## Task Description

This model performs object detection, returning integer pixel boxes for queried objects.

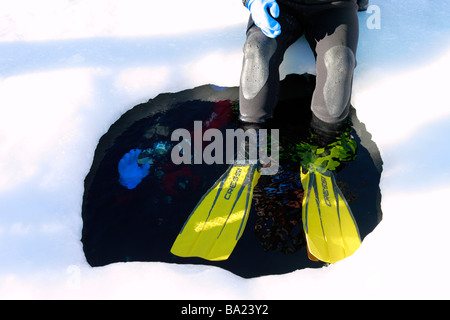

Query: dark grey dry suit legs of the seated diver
[240,0,367,124]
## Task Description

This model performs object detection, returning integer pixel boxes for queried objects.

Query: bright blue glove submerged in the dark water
[119,149,150,189]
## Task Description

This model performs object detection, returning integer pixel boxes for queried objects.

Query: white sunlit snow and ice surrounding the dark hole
[0,0,450,299]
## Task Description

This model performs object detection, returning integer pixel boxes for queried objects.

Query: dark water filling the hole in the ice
[82,75,382,278]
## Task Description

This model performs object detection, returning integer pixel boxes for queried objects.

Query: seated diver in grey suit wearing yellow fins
[171,0,368,263]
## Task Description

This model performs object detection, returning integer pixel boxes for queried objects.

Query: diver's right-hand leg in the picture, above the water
[306,0,359,124]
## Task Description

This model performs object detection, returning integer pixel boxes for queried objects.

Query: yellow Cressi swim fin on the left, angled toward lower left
[170,164,261,261]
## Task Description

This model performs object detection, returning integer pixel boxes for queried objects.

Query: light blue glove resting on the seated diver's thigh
[247,0,281,38]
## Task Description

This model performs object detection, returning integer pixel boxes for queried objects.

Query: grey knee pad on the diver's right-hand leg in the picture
[323,46,356,122]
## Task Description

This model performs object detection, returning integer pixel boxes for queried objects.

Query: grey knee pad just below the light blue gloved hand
[241,33,277,100]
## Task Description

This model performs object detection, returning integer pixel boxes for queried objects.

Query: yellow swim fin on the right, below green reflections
[300,168,361,263]
